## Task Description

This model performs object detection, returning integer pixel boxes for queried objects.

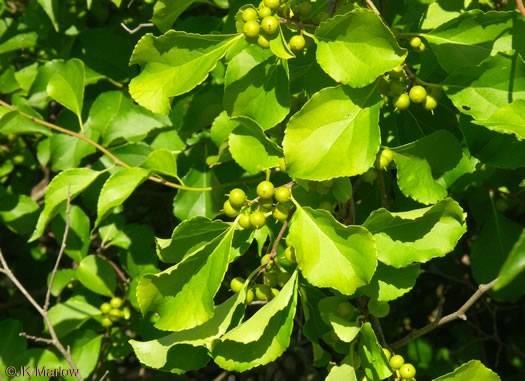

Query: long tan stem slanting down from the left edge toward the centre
[0,99,213,192]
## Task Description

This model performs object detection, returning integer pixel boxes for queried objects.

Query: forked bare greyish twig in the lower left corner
[0,188,83,381]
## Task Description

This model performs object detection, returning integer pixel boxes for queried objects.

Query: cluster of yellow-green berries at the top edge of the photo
[242,0,312,53]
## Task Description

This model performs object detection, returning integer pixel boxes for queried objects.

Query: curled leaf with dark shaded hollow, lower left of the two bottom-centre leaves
[130,289,246,374]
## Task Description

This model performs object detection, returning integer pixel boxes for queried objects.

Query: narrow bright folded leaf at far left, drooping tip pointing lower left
[29,168,102,242]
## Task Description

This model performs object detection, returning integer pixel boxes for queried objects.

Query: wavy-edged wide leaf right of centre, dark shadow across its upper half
[363,199,467,268]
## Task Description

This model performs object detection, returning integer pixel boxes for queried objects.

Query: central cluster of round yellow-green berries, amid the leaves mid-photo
[223,180,291,229]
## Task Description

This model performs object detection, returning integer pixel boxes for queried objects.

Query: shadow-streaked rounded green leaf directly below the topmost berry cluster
[224,45,290,130]
